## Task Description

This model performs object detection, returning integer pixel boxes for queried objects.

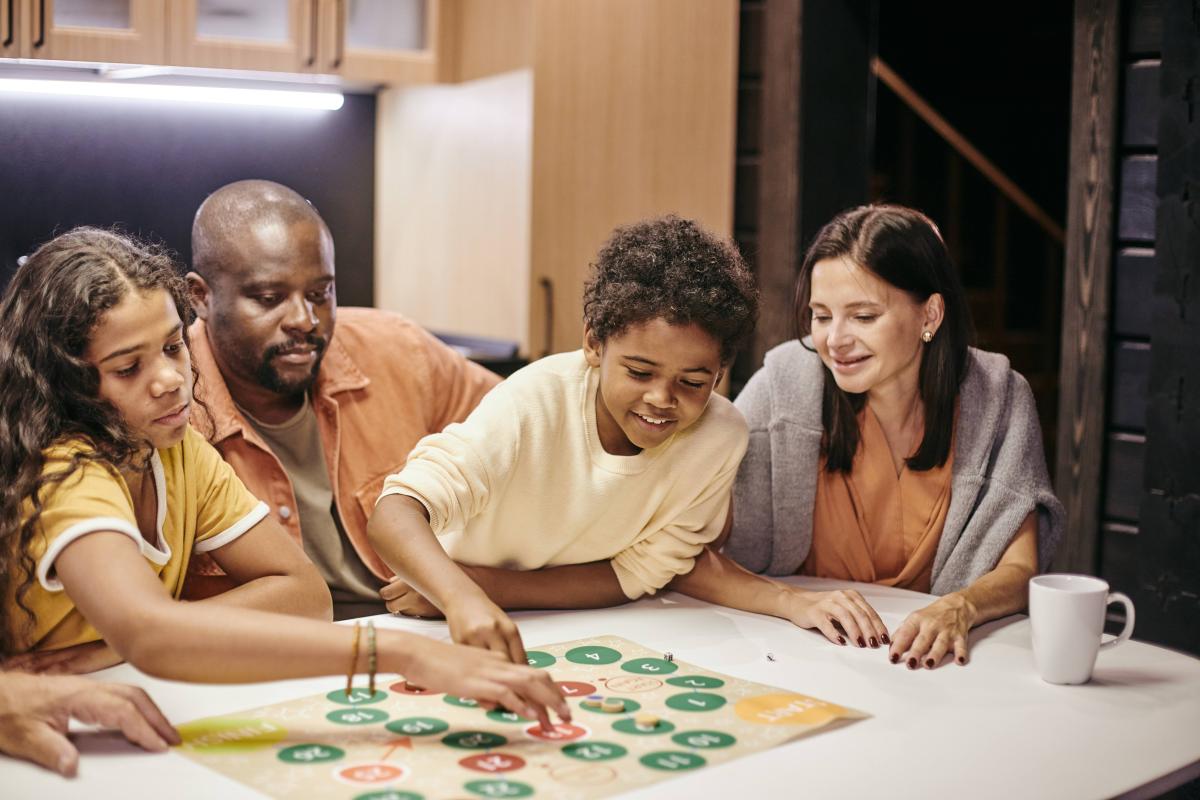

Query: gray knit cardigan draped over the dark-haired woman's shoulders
[725,339,1064,595]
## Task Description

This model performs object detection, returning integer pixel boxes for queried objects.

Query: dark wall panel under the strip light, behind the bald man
[0,95,374,305]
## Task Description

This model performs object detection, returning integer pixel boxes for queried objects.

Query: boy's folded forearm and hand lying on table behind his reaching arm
[379,560,629,616]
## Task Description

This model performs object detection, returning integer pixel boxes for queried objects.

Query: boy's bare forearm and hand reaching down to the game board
[367,494,526,664]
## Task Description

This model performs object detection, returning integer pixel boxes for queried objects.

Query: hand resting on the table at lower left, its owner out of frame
[0,673,179,777]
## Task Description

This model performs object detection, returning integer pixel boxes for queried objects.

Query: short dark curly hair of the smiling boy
[583,215,758,363]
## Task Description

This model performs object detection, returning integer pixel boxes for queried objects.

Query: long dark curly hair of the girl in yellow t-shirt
[0,228,190,656]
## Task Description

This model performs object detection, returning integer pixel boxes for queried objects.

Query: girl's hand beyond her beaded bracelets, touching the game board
[404,640,571,730]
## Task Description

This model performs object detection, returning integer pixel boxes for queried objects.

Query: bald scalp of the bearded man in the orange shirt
[192,180,332,281]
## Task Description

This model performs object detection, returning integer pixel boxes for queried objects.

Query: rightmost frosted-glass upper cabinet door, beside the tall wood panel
[317,0,443,84]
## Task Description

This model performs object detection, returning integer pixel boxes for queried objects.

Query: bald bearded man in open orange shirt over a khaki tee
[185,180,499,619]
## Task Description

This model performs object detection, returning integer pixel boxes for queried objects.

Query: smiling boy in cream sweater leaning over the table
[368,217,757,661]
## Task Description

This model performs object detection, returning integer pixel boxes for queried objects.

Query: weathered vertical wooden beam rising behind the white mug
[1054,0,1121,572]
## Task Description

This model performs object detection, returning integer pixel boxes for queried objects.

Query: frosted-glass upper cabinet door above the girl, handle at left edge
[24,0,167,64]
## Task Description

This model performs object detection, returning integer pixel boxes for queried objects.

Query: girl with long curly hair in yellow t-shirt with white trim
[0,228,568,723]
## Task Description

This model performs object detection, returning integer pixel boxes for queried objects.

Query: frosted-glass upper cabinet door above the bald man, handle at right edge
[169,0,319,72]
